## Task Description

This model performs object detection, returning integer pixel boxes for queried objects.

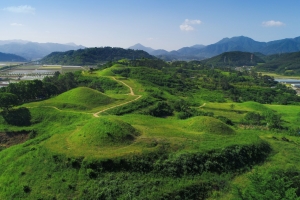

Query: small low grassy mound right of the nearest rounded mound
[187,116,235,135]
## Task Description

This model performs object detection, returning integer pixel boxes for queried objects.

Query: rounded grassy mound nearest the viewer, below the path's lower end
[70,117,138,147]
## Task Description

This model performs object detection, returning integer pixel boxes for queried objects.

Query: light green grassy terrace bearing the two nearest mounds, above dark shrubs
[39,114,259,159]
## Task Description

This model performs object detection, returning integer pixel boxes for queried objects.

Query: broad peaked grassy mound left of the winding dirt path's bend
[45,87,114,110]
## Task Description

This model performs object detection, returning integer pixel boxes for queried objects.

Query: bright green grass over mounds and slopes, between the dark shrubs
[0,65,300,199]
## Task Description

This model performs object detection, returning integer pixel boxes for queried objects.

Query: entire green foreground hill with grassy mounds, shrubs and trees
[0,55,300,199]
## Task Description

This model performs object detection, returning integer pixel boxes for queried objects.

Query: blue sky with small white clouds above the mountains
[0,0,300,50]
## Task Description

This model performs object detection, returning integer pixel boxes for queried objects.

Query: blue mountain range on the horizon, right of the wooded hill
[129,36,300,60]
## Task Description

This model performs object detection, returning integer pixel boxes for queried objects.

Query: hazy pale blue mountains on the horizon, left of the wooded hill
[0,40,85,60]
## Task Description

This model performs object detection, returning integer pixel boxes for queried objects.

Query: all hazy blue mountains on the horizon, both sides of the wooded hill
[0,36,300,61]
